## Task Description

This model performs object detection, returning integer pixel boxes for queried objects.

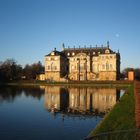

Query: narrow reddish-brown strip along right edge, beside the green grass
[134,81,140,128]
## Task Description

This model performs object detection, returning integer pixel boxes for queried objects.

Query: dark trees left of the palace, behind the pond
[0,59,44,82]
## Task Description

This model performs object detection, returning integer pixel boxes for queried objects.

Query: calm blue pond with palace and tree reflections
[0,86,124,140]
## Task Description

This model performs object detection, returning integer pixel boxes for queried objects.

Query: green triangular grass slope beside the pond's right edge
[89,85,135,136]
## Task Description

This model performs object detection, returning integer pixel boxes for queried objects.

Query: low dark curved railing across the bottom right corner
[84,129,140,140]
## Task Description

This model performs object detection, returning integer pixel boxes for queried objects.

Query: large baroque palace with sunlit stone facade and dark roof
[45,42,120,81]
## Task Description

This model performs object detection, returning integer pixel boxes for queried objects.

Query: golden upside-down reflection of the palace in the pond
[44,86,120,113]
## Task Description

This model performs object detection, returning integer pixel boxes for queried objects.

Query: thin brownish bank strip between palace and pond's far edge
[0,80,132,88]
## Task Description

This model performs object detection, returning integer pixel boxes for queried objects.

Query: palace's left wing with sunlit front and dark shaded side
[45,49,68,81]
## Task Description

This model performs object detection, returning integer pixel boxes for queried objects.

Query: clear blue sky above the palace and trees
[0,0,140,69]
